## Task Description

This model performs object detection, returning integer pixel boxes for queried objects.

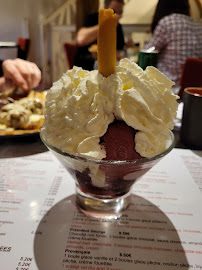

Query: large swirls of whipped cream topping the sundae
[43,59,178,159]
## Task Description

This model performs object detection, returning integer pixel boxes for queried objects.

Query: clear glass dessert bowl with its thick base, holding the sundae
[40,129,174,219]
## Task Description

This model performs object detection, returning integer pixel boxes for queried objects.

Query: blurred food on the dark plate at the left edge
[0,89,47,138]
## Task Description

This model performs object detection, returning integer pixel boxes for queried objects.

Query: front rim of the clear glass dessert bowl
[40,128,175,165]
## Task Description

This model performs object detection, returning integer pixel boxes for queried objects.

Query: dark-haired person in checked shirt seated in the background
[145,0,202,85]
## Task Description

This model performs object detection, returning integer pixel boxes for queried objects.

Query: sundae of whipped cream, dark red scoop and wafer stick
[41,10,178,219]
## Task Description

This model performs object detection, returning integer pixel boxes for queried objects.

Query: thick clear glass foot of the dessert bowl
[76,186,131,220]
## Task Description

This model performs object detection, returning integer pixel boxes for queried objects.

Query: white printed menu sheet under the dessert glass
[0,149,202,270]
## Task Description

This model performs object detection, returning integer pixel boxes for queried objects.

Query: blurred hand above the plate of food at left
[2,58,41,91]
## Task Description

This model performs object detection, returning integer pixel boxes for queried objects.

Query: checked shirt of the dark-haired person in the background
[145,13,202,84]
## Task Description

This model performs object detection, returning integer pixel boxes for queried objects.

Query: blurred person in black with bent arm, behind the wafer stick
[75,0,129,70]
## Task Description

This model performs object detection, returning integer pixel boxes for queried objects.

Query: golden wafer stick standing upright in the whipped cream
[98,9,117,77]
